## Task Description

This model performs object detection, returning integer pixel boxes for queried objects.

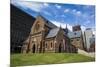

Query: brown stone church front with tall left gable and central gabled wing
[22,16,77,53]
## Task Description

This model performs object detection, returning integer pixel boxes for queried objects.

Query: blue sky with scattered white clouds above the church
[11,0,95,31]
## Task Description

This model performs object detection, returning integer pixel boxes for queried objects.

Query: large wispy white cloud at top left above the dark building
[11,0,44,12]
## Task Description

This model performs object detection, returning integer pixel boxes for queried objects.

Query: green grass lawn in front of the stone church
[10,53,95,67]
